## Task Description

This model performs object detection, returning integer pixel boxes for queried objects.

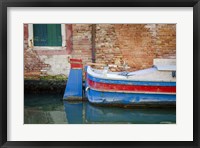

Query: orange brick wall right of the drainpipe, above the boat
[96,24,176,70]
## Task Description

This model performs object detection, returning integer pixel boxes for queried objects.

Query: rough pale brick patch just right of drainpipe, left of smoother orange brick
[95,24,123,64]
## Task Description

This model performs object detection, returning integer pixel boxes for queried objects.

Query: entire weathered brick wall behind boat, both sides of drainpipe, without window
[24,24,176,76]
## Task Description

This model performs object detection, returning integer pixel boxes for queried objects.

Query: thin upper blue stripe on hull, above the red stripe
[87,74,176,86]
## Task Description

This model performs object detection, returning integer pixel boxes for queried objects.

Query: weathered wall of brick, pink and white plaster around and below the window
[24,24,72,79]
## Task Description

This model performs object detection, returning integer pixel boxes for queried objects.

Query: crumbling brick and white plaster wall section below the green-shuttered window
[24,48,70,78]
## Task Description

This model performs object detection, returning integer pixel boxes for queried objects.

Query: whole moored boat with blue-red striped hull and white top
[85,59,176,107]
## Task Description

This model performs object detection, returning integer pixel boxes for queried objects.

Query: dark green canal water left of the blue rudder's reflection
[24,94,68,124]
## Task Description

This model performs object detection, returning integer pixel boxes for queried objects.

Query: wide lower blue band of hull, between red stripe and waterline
[87,89,176,105]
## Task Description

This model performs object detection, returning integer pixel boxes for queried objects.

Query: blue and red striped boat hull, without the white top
[86,65,176,106]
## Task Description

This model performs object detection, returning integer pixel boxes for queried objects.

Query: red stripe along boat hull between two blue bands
[87,79,176,93]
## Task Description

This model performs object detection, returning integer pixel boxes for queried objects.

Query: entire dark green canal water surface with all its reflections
[24,94,176,124]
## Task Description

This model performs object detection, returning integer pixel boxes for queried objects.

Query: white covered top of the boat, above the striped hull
[87,59,176,82]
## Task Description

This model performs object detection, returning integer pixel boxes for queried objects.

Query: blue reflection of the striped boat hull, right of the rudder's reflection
[86,104,176,124]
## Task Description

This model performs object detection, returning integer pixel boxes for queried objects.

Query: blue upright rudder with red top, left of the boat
[63,59,83,101]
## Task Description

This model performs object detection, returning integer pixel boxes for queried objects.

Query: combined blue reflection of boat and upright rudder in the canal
[64,101,176,124]
